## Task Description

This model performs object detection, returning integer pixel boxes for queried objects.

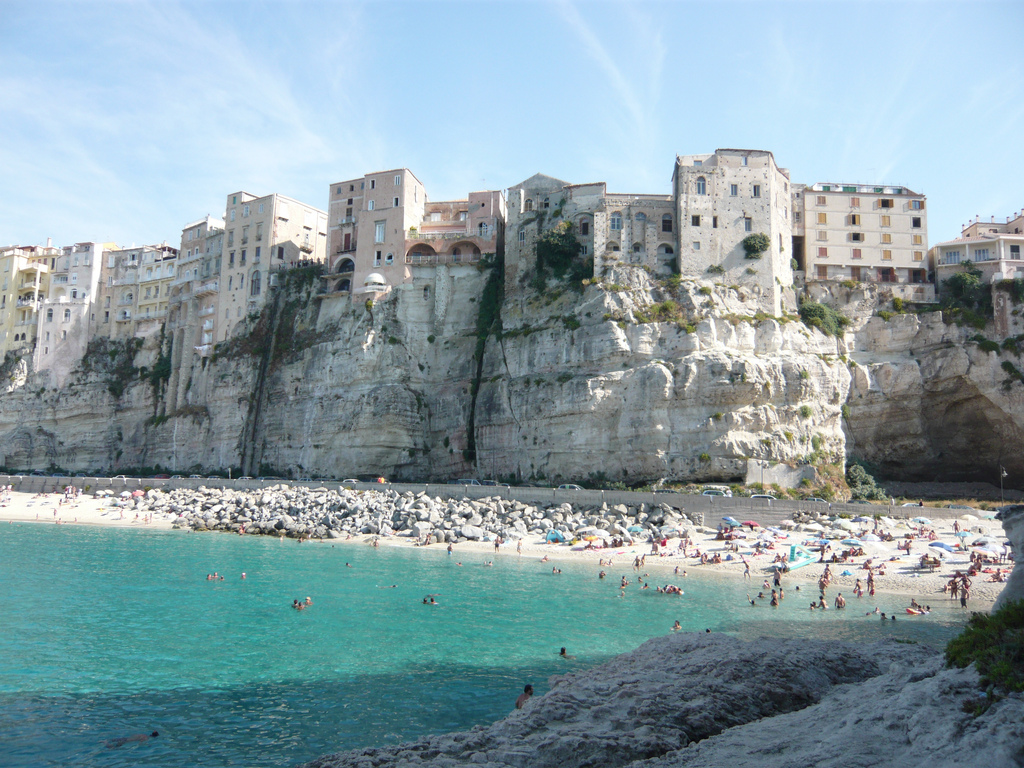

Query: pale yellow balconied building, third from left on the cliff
[92,243,178,340]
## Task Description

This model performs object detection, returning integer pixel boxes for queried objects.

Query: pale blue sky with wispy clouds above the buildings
[0,0,1024,245]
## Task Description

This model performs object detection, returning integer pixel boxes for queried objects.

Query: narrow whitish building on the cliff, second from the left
[33,243,109,386]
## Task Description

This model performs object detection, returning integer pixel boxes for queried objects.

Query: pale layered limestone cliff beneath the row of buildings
[0,265,1024,481]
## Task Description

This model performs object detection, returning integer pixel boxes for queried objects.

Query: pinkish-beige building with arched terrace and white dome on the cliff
[325,168,505,296]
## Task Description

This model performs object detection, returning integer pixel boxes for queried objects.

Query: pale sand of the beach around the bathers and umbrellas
[0,492,1013,610]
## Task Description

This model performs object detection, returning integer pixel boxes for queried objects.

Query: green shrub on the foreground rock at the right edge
[946,600,1024,691]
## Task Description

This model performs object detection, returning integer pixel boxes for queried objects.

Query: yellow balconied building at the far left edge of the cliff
[0,243,60,359]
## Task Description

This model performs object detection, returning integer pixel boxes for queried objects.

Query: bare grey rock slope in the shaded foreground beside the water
[306,634,1024,768]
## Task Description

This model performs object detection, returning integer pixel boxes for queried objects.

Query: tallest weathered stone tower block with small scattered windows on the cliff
[672,150,796,315]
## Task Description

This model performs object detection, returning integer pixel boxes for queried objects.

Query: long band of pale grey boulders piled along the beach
[126,485,703,543]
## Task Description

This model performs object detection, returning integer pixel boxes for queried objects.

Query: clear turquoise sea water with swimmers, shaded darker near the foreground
[0,524,964,768]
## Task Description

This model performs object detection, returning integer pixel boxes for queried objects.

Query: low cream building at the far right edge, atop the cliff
[930,211,1024,293]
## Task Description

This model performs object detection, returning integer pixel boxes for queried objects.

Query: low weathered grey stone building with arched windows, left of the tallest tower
[505,173,678,293]
